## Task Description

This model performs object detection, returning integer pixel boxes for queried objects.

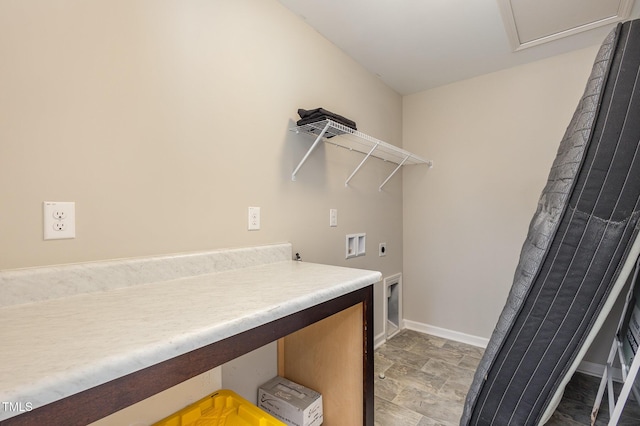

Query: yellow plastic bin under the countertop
[154,389,287,426]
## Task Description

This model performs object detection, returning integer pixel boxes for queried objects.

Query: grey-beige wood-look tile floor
[375,330,640,426]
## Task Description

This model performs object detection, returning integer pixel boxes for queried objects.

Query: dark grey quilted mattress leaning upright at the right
[460,21,640,426]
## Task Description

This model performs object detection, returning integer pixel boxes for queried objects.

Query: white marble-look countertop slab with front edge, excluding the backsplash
[0,255,381,420]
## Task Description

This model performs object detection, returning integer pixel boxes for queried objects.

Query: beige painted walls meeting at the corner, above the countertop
[0,0,624,402]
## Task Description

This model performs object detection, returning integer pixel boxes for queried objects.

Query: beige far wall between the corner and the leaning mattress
[403,46,609,360]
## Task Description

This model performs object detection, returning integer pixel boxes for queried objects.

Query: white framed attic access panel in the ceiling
[498,0,635,51]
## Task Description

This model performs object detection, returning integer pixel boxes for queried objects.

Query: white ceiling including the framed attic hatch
[279,0,640,95]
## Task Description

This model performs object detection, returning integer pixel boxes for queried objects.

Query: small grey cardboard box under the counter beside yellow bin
[258,376,322,426]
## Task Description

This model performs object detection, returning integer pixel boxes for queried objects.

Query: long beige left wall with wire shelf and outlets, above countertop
[0,0,402,340]
